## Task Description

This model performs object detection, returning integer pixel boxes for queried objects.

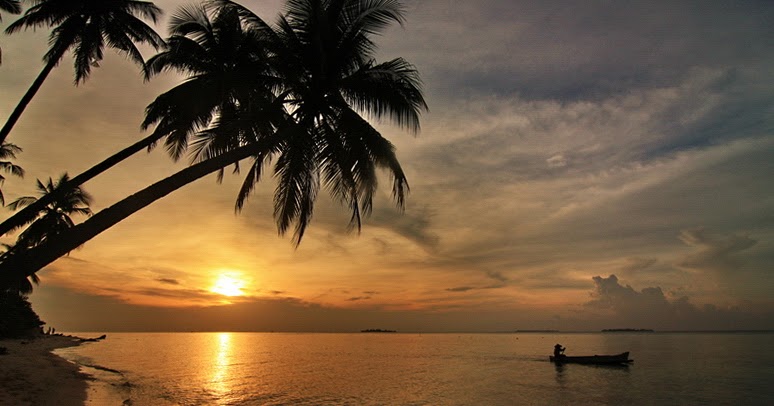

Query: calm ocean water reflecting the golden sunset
[57,333,774,405]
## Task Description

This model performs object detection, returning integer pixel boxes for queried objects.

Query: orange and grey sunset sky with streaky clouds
[0,0,774,332]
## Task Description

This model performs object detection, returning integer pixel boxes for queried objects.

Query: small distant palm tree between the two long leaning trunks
[0,173,92,295]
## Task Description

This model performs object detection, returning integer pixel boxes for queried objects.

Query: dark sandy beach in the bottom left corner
[0,335,88,406]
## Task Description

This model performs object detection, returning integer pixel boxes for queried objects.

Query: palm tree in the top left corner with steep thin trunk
[0,0,163,142]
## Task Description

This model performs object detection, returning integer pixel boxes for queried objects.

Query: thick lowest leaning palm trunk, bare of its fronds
[0,140,268,287]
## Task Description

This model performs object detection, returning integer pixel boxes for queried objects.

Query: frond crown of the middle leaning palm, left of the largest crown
[142,2,281,160]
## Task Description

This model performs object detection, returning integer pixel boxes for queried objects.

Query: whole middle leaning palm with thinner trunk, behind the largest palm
[0,0,273,235]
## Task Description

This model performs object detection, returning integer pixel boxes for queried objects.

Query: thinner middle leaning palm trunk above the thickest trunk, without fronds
[0,133,162,236]
